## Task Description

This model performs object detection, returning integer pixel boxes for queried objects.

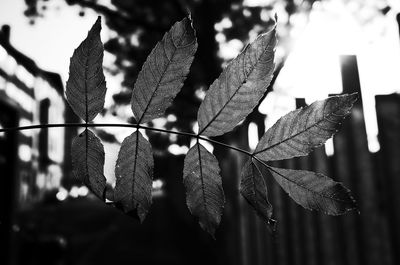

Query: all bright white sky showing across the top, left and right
[0,0,400,156]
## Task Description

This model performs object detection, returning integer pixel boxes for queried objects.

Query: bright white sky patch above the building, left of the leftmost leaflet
[0,0,96,81]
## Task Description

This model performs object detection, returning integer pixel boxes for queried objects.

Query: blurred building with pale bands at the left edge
[0,23,65,262]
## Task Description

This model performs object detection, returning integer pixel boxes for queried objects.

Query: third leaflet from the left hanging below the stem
[183,143,225,237]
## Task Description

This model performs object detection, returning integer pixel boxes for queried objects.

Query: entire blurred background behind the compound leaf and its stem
[0,0,400,265]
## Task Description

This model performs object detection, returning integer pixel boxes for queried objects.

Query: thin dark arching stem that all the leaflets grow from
[0,123,252,156]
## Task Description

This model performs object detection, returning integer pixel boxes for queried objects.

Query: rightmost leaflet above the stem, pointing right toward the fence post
[254,93,357,161]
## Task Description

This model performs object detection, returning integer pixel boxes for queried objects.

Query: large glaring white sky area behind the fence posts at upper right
[267,0,400,152]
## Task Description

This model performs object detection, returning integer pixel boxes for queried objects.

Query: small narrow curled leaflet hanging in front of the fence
[240,159,272,223]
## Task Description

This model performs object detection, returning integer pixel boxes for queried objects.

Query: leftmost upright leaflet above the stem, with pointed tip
[65,17,107,122]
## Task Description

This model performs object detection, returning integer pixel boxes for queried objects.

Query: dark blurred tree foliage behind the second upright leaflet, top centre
[25,0,314,150]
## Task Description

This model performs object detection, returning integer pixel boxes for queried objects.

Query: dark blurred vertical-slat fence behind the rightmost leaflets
[230,46,400,265]
